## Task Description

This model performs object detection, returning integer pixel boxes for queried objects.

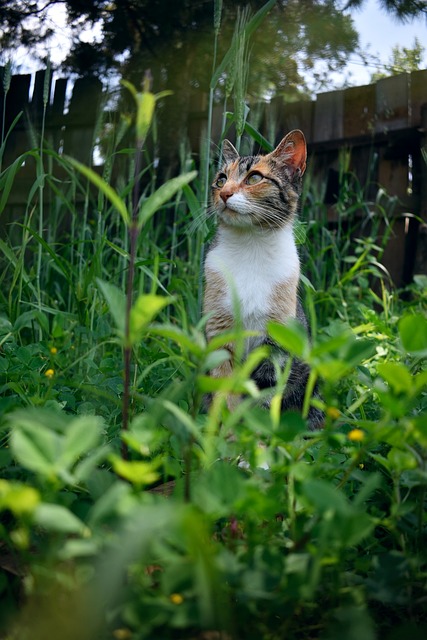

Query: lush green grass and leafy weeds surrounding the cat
[0,16,427,640]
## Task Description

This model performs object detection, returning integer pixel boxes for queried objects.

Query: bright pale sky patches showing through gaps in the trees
[7,0,427,87]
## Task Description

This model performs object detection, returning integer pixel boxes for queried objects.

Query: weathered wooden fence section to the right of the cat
[260,70,427,286]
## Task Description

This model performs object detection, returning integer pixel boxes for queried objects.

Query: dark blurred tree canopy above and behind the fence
[0,0,425,166]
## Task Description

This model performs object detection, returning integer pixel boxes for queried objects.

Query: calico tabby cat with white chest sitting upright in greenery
[203,129,323,429]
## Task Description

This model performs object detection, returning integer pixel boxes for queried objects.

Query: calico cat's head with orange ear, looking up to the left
[212,129,307,229]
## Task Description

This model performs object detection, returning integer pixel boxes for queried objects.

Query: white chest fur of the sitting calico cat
[206,225,299,330]
